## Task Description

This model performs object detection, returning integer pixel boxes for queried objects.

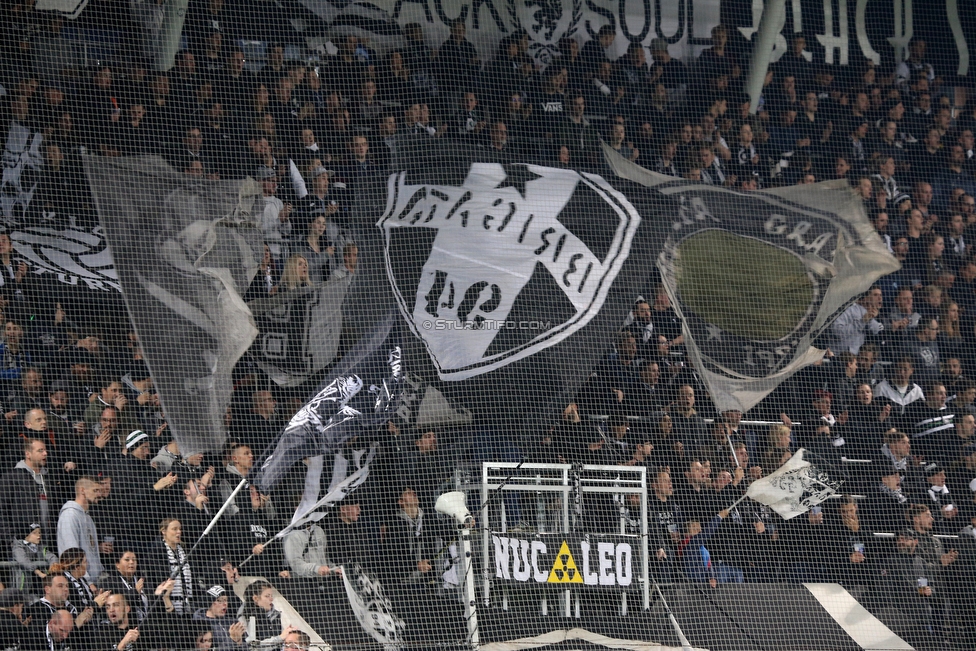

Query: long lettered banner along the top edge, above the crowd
[299,0,976,76]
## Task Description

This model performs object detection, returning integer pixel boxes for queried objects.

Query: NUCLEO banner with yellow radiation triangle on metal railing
[488,533,641,590]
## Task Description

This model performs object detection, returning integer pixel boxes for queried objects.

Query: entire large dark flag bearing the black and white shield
[364,139,656,427]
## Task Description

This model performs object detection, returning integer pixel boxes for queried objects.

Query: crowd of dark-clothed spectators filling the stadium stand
[0,0,976,651]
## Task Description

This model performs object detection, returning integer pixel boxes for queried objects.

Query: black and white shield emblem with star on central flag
[379,163,640,380]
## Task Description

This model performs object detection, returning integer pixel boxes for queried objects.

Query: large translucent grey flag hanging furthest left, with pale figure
[85,157,263,454]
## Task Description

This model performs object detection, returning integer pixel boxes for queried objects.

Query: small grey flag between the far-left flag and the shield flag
[248,274,353,387]
